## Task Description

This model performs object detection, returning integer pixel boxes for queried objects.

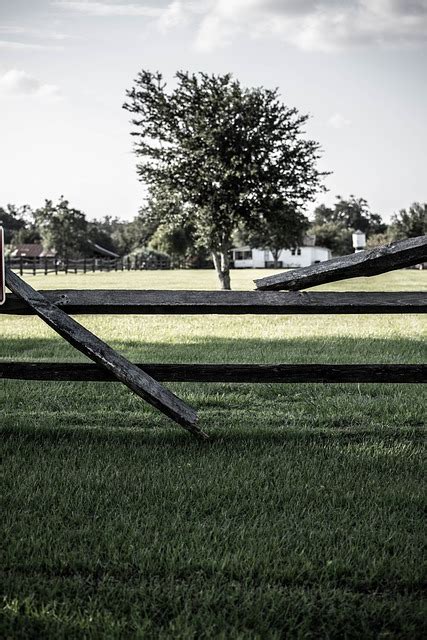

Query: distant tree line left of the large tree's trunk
[0,196,209,267]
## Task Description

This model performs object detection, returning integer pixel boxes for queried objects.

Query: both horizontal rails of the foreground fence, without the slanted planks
[0,289,427,383]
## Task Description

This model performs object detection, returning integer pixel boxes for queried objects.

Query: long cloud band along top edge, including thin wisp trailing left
[51,0,427,52]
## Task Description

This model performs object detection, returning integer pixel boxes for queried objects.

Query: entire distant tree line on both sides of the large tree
[0,192,427,267]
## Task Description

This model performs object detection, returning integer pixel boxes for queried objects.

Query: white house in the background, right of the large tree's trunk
[231,236,332,269]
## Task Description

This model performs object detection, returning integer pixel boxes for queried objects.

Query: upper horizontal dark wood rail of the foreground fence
[0,289,427,315]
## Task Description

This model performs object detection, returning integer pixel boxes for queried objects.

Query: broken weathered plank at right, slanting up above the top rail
[255,236,427,291]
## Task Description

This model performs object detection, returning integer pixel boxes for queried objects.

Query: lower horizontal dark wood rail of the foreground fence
[0,362,427,383]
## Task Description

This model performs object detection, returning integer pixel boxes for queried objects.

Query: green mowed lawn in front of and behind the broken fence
[0,270,427,639]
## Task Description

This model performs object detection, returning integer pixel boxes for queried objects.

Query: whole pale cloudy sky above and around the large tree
[0,0,427,219]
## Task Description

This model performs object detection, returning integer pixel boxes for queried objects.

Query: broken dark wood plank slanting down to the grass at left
[6,268,207,438]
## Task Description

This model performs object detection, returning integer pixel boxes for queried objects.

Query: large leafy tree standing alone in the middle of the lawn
[124,70,323,289]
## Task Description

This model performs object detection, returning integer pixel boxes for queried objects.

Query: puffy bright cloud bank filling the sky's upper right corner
[195,0,427,51]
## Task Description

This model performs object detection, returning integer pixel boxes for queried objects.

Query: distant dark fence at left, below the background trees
[6,256,171,276]
